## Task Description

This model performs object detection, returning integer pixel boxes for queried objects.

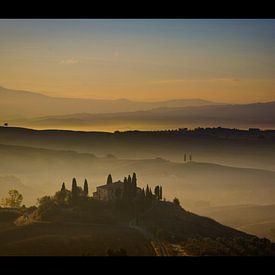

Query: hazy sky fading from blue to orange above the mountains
[0,19,275,102]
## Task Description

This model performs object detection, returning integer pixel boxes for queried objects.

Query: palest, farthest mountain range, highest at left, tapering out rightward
[0,87,219,120]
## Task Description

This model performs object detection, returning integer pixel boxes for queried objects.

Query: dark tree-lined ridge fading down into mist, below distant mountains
[0,127,275,171]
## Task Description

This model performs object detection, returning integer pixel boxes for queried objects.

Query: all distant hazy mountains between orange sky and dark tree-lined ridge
[0,87,275,131]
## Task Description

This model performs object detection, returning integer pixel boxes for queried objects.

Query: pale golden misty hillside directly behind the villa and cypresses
[0,142,275,206]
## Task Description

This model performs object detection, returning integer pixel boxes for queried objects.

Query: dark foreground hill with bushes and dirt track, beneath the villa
[0,177,275,256]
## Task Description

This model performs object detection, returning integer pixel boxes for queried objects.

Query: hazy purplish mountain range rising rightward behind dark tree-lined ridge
[11,102,275,130]
